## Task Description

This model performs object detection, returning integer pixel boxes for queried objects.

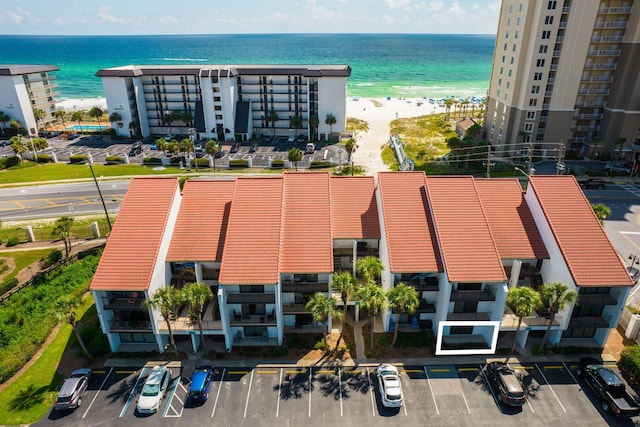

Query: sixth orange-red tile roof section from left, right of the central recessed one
[378,172,443,273]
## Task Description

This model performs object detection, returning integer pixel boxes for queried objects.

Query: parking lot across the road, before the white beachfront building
[0,135,347,168]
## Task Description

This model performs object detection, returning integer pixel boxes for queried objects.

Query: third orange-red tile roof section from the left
[218,177,283,285]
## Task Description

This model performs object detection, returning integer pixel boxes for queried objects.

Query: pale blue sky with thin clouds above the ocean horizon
[0,0,500,35]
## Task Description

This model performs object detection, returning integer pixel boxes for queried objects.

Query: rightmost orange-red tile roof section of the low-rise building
[530,176,633,286]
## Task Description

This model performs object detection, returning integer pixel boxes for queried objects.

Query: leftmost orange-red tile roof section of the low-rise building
[91,177,179,291]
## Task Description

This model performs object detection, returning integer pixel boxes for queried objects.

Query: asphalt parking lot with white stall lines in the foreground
[37,363,633,427]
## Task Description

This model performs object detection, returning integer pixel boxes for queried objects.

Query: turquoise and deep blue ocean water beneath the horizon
[0,34,495,99]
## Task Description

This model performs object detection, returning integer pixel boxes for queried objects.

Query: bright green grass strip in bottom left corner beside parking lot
[0,296,93,425]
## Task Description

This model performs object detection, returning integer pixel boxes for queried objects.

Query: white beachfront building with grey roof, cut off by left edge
[0,64,60,136]
